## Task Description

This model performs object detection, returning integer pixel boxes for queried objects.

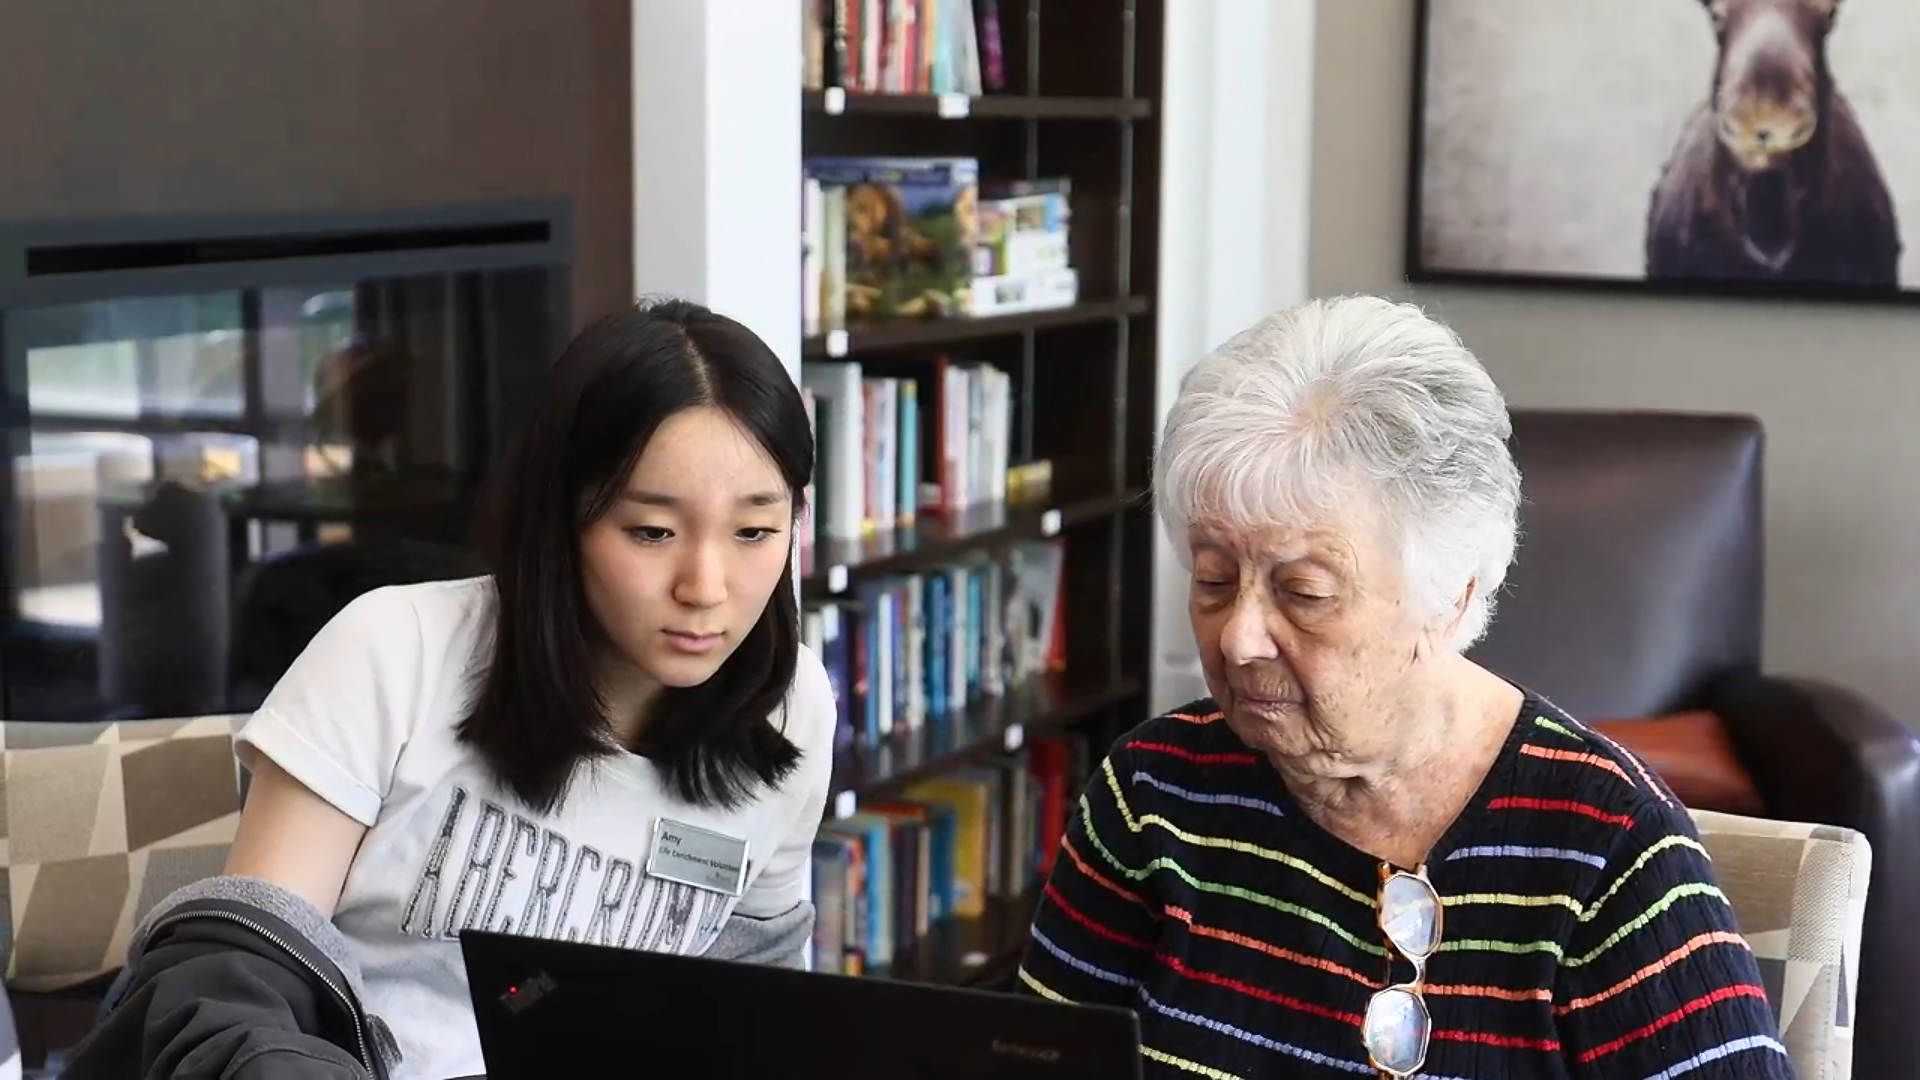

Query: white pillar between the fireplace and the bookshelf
[632,0,803,375]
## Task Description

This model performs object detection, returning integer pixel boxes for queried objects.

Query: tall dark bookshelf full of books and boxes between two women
[793,0,1165,986]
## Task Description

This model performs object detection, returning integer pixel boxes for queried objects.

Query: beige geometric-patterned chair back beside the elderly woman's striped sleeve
[1692,811,1874,1080]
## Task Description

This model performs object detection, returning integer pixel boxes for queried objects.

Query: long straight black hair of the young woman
[459,300,814,811]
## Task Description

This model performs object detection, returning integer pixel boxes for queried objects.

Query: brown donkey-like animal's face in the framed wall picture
[1705,0,1839,173]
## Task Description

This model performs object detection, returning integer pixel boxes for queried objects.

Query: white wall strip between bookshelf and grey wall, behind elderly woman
[1152,0,1315,709]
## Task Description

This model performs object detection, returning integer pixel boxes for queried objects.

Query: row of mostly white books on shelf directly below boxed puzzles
[801,357,1014,538]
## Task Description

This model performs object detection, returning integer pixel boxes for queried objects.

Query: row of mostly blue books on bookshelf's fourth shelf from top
[801,538,1066,748]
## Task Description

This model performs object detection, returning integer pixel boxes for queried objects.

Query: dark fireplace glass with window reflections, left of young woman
[6,271,529,719]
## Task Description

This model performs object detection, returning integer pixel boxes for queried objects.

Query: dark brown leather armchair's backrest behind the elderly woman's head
[1469,409,1763,721]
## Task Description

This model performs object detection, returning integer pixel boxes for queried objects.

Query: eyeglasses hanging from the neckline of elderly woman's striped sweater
[1359,863,1440,1080]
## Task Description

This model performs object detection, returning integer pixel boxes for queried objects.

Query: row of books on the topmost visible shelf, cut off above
[801,0,1006,96]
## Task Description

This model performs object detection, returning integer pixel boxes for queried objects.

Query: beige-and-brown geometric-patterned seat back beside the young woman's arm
[0,717,246,990]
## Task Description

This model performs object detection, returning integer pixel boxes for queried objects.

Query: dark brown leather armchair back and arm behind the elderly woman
[1473,409,1920,1076]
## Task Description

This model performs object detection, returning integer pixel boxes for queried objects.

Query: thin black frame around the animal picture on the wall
[1402,0,1920,307]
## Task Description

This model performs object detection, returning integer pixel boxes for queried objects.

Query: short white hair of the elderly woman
[1154,296,1521,651]
